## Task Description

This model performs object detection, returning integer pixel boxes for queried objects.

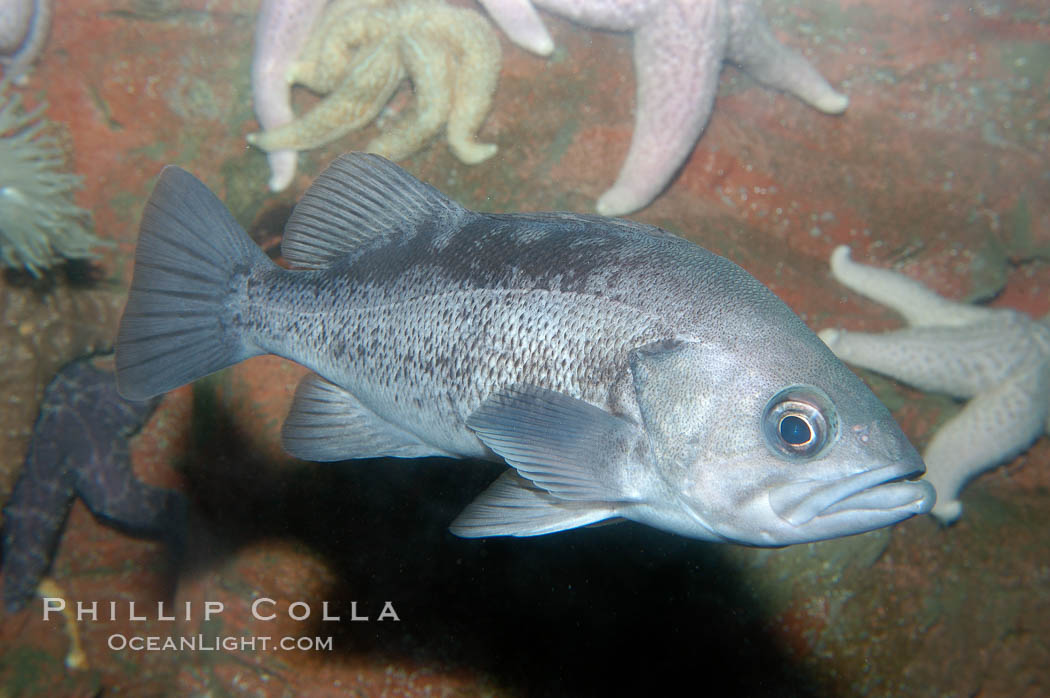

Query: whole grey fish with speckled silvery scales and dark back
[117,153,935,546]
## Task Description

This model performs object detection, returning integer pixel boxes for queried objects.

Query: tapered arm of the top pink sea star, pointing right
[727,2,849,114]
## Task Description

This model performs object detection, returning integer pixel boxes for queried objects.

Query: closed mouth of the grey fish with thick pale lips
[770,461,937,535]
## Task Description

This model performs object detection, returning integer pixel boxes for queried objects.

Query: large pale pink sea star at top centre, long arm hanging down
[480,0,848,215]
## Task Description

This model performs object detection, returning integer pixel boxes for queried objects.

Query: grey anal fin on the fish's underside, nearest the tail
[280,374,449,461]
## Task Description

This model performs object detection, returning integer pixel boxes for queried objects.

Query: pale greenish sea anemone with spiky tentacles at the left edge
[0,79,103,276]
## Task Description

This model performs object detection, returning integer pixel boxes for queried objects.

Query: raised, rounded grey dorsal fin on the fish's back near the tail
[280,152,467,269]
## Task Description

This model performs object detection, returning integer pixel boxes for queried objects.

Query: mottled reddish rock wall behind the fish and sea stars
[0,0,1050,697]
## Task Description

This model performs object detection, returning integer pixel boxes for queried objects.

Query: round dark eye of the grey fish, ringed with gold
[762,385,836,459]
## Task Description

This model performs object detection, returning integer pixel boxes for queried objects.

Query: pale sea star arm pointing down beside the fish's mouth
[923,364,1050,524]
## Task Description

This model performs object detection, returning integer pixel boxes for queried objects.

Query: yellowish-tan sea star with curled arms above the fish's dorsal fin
[248,0,502,164]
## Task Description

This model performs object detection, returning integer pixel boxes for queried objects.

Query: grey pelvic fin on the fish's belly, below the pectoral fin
[448,470,617,538]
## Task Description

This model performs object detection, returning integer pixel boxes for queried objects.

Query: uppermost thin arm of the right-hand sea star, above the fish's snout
[831,245,988,327]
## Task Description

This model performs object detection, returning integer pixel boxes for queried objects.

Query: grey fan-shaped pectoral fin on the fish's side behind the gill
[466,385,645,503]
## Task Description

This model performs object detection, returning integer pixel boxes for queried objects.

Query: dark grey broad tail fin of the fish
[117,166,273,400]
